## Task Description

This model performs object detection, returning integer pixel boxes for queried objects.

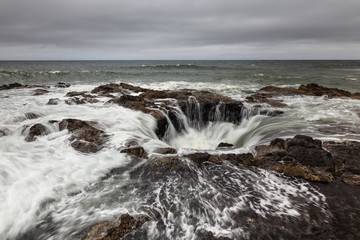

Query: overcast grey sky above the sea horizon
[0,0,360,60]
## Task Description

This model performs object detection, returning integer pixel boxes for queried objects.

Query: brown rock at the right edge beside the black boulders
[323,141,360,185]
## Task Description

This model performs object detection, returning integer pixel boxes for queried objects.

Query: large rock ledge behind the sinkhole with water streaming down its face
[102,84,243,138]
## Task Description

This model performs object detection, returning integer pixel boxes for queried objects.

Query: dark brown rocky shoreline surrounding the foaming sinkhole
[0,83,360,240]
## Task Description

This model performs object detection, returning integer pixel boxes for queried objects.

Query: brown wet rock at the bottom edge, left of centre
[83,214,150,240]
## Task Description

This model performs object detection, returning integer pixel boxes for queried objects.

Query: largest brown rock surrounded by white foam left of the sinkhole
[59,119,108,153]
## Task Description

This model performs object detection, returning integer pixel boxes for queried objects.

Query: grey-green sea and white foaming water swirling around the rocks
[0,60,360,240]
